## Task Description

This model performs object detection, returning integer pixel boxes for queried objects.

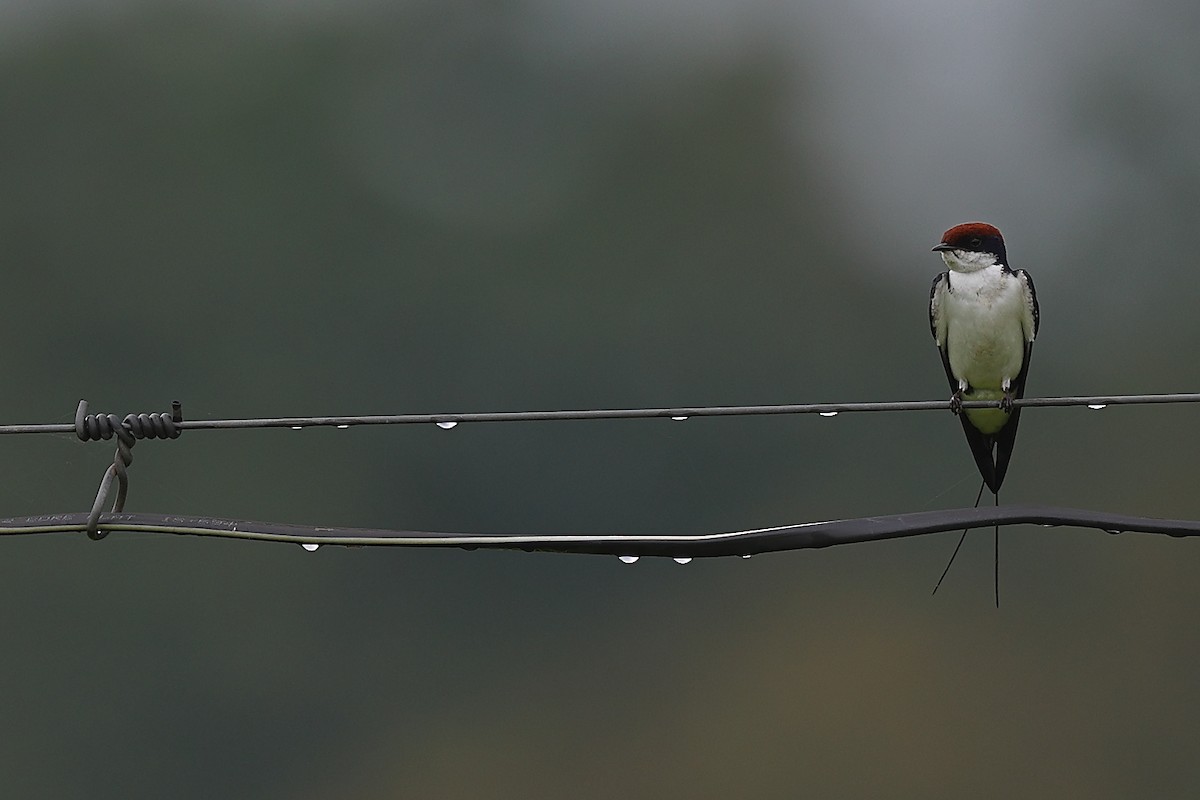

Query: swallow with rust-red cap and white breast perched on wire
[929,222,1040,607]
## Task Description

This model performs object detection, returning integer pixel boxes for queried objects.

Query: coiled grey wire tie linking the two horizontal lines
[76,399,184,541]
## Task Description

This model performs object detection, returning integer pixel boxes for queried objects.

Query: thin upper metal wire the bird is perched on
[0,392,1200,434]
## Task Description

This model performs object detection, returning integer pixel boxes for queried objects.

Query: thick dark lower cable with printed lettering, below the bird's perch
[0,506,1200,561]
